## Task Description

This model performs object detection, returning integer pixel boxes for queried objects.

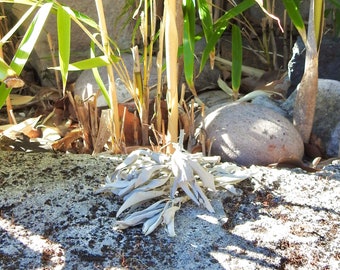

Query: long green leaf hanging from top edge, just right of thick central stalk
[183,0,196,95]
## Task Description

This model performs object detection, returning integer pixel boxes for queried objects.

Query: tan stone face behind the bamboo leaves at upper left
[9,0,133,85]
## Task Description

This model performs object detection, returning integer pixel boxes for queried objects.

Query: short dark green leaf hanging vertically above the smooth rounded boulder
[231,25,242,98]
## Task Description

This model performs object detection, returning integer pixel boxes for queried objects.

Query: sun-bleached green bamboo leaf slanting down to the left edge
[0,3,53,108]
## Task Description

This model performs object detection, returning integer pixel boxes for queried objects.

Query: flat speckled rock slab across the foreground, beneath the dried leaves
[0,151,340,269]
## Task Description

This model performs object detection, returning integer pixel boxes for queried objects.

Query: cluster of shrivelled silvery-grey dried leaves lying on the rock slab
[99,147,251,236]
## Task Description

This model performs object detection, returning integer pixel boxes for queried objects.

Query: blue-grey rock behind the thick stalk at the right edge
[282,79,340,157]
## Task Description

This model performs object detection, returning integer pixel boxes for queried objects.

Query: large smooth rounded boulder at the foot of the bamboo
[205,103,304,166]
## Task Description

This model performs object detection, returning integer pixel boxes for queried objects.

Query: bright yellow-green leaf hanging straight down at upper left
[57,6,71,91]
